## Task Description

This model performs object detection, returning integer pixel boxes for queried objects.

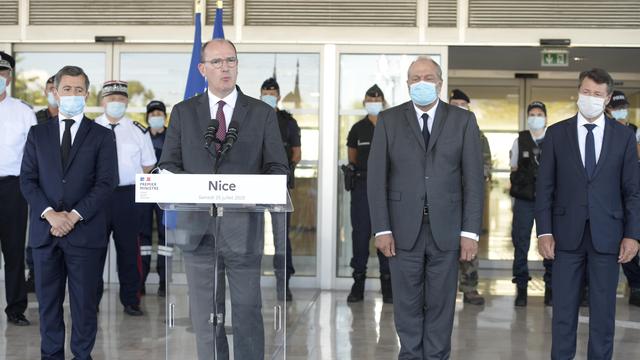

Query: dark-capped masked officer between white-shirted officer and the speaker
[138,100,173,297]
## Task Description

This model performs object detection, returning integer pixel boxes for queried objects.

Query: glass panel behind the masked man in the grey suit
[337,54,440,277]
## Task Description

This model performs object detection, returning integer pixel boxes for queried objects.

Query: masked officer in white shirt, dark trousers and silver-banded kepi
[96,80,157,316]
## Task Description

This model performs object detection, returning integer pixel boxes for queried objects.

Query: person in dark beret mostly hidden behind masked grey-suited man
[449,89,492,305]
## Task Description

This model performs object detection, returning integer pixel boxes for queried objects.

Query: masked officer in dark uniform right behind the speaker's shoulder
[260,78,302,301]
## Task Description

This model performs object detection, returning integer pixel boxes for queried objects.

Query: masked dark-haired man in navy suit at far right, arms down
[535,69,640,360]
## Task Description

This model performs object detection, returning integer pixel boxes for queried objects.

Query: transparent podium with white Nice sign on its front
[136,174,293,360]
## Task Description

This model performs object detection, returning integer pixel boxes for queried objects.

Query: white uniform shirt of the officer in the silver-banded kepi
[96,114,158,186]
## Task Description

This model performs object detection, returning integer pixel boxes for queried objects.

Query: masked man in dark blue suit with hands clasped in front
[20,66,117,360]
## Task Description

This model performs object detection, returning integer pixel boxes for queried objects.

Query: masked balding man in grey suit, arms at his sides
[367,57,484,359]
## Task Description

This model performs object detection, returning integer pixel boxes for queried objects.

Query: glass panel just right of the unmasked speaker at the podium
[238,53,320,276]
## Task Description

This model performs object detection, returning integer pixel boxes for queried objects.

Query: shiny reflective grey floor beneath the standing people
[0,271,640,360]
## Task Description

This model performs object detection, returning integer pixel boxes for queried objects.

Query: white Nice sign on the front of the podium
[136,174,287,204]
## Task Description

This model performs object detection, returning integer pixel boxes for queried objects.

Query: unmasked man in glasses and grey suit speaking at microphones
[158,39,288,359]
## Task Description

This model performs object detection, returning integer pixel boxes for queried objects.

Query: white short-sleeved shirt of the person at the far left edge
[0,95,37,177]
